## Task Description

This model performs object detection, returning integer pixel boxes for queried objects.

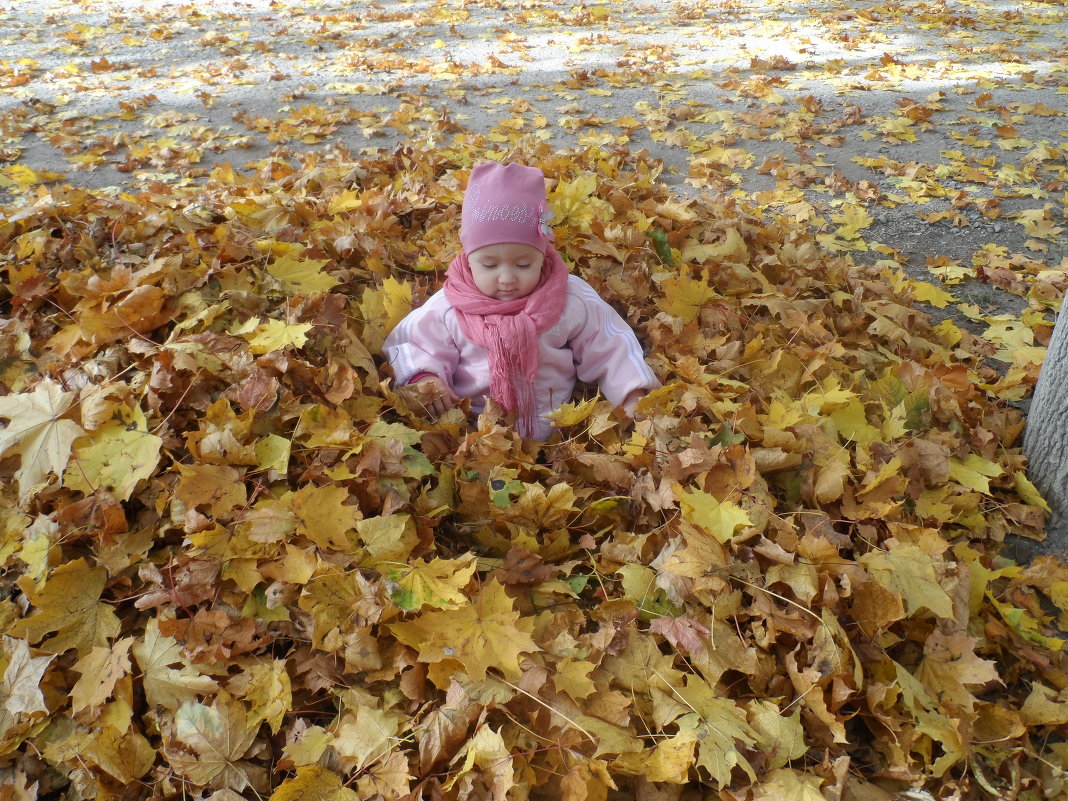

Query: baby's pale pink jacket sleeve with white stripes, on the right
[570,281,660,405]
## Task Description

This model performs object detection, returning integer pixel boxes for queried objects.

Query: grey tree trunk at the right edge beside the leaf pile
[1022,304,1068,556]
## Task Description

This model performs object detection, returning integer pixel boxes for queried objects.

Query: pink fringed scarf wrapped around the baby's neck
[445,245,567,436]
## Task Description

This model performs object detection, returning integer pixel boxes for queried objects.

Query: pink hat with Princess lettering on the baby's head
[460,161,553,253]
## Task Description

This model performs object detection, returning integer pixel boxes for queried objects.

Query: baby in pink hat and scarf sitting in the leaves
[382,162,660,440]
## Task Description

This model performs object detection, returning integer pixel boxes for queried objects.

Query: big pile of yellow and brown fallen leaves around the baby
[0,138,1068,801]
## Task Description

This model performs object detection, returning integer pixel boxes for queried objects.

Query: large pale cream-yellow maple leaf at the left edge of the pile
[0,379,84,501]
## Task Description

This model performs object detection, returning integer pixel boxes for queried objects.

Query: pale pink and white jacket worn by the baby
[382,276,660,439]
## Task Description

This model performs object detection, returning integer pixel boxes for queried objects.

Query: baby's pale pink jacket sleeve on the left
[382,298,459,389]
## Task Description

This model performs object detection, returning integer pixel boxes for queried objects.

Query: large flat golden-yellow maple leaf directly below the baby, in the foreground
[389,580,540,681]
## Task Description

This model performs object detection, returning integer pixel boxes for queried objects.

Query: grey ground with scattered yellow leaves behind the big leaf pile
[0,0,1068,410]
